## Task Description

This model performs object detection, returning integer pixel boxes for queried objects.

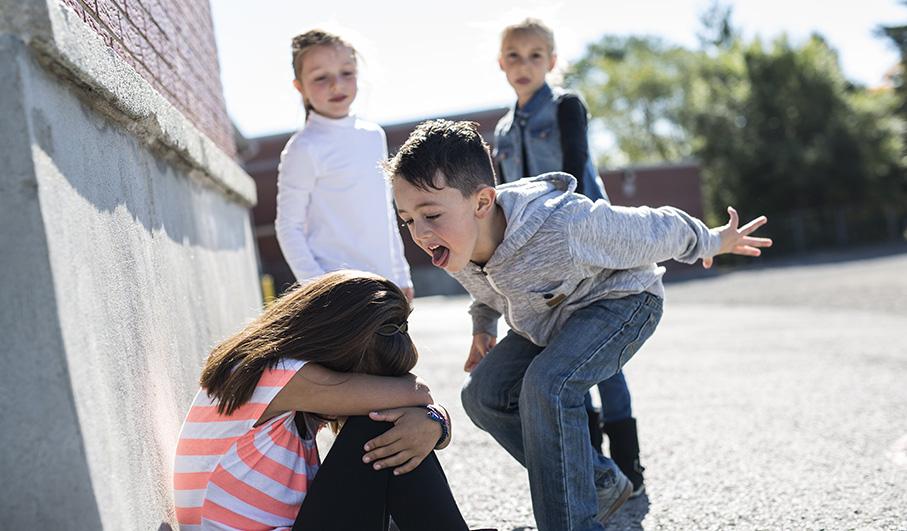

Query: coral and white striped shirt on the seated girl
[173,358,320,531]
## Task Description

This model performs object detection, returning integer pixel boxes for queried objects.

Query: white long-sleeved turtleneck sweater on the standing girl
[274,111,412,288]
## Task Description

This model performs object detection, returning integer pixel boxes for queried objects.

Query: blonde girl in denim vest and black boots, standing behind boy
[494,18,645,497]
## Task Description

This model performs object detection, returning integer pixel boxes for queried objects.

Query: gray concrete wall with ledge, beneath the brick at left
[0,0,260,530]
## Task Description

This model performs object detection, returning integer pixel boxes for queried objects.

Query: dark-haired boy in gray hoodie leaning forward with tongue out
[385,120,771,531]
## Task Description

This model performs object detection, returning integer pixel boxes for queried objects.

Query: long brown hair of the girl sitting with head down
[200,270,418,415]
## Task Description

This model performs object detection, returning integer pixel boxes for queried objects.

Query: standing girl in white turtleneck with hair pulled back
[275,30,413,299]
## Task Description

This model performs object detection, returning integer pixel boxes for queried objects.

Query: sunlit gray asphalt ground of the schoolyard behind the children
[411,250,907,531]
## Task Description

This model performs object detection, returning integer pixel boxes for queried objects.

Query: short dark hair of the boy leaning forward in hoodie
[384,120,497,197]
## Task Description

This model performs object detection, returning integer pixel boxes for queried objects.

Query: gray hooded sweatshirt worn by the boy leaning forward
[452,172,721,346]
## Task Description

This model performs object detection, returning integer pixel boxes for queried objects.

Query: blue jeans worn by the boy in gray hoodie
[461,293,662,531]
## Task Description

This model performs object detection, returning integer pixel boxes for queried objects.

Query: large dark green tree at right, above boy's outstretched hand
[688,35,903,224]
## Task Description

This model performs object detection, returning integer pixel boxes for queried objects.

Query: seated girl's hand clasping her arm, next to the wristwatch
[362,407,441,476]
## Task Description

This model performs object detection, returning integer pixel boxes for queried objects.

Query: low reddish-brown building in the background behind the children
[243,107,703,296]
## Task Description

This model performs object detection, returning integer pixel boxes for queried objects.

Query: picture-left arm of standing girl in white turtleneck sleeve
[274,139,325,282]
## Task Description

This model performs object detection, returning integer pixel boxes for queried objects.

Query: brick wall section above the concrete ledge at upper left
[59,0,236,156]
